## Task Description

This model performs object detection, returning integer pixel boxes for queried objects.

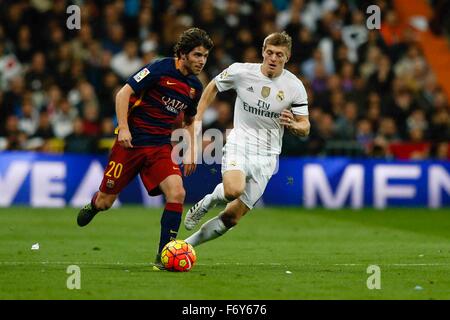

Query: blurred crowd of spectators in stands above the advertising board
[0,0,450,159]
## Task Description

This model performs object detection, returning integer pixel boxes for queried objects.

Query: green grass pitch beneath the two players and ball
[0,205,450,300]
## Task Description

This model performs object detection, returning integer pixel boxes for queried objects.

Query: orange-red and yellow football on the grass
[161,240,197,272]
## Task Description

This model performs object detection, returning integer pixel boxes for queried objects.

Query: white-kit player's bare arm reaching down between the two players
[184,79,218,176]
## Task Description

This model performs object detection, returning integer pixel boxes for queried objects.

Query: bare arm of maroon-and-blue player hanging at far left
[116,84,134,148]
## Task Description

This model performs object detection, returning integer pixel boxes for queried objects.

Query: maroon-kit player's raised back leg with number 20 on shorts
[77,142,145,227]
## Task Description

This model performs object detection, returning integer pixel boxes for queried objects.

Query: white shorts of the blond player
[222,144,278,209]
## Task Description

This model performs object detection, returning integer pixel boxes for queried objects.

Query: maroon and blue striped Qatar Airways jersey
[127,58,203,147]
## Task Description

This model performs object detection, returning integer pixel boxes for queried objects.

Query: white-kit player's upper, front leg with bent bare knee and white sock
[184,170,245,230]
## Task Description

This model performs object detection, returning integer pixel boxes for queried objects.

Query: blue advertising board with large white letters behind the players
[0,152,450,208]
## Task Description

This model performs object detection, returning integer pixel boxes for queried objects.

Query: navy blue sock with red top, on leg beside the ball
[158,203,183,253]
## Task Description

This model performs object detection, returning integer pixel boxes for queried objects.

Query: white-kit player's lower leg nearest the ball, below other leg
[185,198,250,246]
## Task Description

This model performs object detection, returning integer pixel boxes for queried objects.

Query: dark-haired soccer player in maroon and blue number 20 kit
[77,28,213,269]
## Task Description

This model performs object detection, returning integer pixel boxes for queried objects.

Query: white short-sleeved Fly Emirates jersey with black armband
[214,63,308,155]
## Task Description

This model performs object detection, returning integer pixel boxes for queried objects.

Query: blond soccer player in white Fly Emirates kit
[184,32,310,246]
